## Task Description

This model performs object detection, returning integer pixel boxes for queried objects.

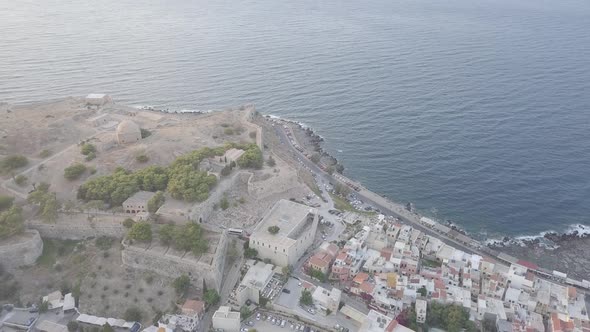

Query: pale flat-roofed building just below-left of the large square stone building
[236,261,274,306]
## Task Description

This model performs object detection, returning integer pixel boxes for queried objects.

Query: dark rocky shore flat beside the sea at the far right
[496,237,590,280]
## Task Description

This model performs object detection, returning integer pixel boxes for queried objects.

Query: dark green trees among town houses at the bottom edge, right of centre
[396,301,479,332]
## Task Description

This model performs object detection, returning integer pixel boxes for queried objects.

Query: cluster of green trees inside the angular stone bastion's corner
[158,222,209,255]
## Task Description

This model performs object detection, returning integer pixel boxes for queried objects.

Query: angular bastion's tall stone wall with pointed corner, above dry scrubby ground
[121,232,227,291]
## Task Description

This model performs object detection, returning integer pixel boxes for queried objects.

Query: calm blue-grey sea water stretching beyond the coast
[0,0,590,239]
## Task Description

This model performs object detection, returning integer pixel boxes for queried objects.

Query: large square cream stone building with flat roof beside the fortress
[250,199,318,266]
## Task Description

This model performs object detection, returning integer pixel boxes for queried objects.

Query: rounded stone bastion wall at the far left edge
[0,230,43,269]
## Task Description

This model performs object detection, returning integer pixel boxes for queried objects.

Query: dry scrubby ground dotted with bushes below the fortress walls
[13,239,176,321]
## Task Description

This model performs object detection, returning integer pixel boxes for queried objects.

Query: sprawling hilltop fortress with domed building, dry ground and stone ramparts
[0,94,310,296]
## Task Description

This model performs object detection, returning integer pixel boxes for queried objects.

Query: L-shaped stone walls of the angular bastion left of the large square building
[121,231,227,291]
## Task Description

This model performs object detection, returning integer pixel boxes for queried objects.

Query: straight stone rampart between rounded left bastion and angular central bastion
[26,213,126,240]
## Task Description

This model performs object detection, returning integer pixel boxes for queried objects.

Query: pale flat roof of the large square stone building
[252,199,315,241]
